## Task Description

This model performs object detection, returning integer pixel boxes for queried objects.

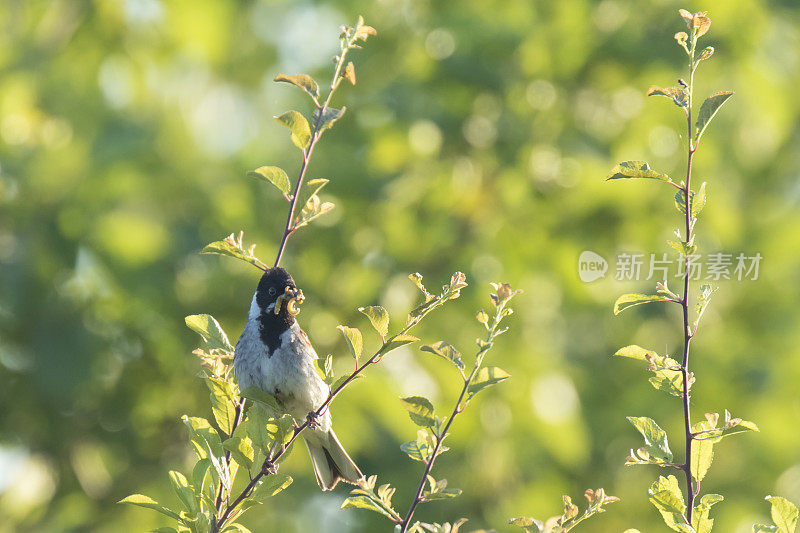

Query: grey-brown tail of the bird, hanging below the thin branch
[303,428,364,490]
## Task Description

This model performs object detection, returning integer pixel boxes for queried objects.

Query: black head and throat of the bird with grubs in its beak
[256,267,304,349]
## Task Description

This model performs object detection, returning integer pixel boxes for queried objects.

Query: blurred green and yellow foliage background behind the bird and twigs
[0,0,800,532]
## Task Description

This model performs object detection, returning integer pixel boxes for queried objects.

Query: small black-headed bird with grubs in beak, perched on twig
[233,266,364,491]
